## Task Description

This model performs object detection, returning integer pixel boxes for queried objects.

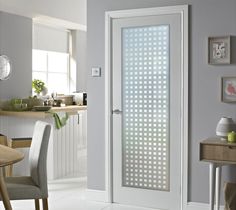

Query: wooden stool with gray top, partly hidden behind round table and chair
[6,137,32,176]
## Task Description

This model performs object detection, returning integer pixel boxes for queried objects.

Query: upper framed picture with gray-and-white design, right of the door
[208,36,231,64]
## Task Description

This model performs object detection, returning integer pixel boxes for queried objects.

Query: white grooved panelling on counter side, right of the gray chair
[48,111,87,179]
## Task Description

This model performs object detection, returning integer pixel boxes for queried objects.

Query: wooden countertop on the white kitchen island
[0,105,87,118]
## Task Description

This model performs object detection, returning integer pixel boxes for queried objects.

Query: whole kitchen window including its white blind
[32,23,76,94]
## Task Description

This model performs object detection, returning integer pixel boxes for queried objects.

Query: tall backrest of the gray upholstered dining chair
[29,121,51,196]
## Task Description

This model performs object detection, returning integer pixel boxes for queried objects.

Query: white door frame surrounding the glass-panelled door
[104,5,189,210]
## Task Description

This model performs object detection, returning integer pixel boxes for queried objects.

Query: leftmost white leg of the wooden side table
[209,163,216,210]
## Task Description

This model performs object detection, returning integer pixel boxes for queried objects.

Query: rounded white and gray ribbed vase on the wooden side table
[216,117,236,140]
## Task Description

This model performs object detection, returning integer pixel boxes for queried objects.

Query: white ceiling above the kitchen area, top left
[0,0,87,25]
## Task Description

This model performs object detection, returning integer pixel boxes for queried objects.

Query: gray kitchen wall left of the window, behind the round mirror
[0,12,32,99]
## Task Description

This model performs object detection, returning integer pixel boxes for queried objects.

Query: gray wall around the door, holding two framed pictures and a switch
[87,0,236,202]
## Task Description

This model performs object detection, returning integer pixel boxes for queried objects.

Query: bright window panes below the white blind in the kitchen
[33,49,70,93]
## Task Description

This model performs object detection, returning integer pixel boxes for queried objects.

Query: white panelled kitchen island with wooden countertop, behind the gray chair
[0,106,87,180]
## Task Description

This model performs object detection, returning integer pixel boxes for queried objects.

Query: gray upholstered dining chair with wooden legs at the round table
[3,121,51,210]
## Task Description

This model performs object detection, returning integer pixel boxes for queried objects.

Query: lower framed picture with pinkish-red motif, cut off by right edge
[221,77,236,103]
